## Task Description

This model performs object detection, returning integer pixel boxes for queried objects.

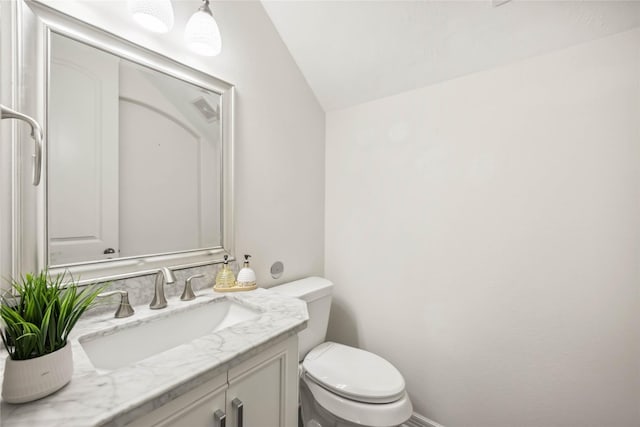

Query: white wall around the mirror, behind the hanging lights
[29,0,325,286]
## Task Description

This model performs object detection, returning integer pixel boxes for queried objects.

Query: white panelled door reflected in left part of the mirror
[48,34,119,265]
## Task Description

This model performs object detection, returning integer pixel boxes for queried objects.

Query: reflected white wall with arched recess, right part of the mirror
[118,61,221,256]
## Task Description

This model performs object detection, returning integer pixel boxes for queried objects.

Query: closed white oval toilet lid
[302,342,404,403]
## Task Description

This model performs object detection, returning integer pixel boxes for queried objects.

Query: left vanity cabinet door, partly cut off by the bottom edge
[127,375,229,427]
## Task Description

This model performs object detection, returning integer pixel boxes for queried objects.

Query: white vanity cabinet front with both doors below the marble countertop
[128,335,298,427]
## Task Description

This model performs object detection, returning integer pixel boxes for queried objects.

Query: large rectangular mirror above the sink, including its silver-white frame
[13,2,234,281]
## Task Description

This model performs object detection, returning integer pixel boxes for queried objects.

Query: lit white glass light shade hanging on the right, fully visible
[184,0,222,56]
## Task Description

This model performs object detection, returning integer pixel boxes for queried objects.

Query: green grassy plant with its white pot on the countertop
[0,271,106,403]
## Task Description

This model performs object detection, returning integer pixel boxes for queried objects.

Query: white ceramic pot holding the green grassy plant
[2,342,73,403]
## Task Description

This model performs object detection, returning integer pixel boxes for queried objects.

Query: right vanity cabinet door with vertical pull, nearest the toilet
[227,336,298,427]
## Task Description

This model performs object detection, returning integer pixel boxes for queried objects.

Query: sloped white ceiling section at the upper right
[263,0,640,111]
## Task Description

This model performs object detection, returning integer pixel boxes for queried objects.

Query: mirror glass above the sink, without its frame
[47,32,223,266]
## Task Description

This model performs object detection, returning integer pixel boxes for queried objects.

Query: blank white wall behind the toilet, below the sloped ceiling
[325,30,640,427]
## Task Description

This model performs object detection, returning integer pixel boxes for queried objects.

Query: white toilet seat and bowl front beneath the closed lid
[301,374,413,427]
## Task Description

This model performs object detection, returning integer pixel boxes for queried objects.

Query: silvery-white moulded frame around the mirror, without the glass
[11,0,235,283]
